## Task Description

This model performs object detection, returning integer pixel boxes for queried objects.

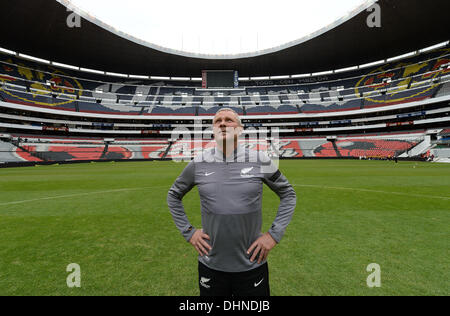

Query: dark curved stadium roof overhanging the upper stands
[0,0,450,77]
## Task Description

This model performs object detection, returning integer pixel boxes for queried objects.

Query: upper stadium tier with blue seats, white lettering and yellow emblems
[0,43,450,116]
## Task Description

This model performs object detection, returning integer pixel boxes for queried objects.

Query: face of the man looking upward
[213,111,242,142]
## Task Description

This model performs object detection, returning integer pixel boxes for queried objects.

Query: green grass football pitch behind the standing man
[0,160,450,296]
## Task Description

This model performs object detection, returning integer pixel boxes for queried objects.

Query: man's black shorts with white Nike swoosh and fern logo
[198,262,270,296]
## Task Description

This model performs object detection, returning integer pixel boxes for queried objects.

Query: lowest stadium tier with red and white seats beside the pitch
[0,131,440,162]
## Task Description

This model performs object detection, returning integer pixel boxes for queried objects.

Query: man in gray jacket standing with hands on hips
[167,108,297,296]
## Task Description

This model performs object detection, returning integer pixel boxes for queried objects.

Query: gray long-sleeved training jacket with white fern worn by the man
[167,145,297,272]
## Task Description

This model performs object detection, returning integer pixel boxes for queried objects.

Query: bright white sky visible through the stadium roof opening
[67,0,367,55]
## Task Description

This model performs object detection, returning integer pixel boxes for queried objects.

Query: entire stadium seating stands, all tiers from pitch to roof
[0,44,450,162]
